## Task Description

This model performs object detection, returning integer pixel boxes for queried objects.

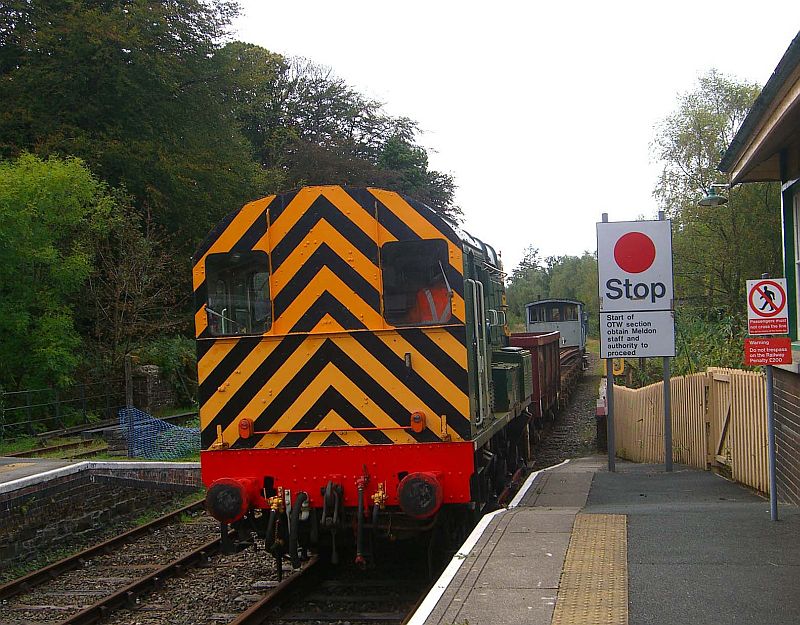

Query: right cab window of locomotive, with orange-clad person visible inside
[381,239,453,326]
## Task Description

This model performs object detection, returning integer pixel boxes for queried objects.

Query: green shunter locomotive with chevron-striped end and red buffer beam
[193,186,533,565]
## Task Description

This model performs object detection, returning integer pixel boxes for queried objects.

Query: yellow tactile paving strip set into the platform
[552,514,628,625]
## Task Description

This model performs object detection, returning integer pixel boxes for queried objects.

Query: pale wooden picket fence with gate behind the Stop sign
[614,368,769,493]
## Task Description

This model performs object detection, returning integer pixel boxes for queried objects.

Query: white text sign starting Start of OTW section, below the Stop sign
[600,310,675,358]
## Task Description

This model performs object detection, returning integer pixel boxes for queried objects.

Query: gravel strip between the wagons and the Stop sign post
[533,354,600,469]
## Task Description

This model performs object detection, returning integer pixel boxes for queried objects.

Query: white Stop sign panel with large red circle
[597,220,673,312]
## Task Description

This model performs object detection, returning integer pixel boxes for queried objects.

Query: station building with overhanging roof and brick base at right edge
[719,33,800,504]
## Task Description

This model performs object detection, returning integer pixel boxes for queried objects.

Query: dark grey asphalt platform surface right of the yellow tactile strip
[584,463,800,625]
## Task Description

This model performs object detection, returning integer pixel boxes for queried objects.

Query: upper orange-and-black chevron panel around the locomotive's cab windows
[193,187,466,338]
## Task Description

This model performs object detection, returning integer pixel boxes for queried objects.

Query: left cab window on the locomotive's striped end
[206,252,272,336]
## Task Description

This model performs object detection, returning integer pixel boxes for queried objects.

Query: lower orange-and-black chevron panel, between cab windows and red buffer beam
[199,319,471,449]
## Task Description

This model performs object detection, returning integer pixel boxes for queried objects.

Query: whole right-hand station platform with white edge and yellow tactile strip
[409,456,800,625]
